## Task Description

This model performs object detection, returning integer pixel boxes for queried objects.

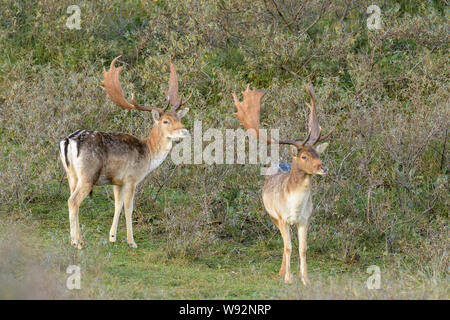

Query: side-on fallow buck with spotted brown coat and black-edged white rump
[59,56,189,249]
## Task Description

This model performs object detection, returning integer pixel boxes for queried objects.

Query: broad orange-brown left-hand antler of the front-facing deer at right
[233,85,309,148]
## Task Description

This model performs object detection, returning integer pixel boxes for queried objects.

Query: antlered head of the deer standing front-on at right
[233,82,333,175]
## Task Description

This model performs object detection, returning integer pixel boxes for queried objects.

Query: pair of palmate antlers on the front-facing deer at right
[233,83,332,148]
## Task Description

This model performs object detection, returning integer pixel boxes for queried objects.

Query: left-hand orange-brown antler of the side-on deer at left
[103,56,167,113]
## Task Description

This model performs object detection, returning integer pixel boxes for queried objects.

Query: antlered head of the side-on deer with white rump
[103,56,190,139]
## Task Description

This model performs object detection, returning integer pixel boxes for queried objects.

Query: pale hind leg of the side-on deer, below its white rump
[67,180,93,249]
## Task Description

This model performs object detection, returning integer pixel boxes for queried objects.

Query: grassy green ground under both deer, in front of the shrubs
[0,188,449,299]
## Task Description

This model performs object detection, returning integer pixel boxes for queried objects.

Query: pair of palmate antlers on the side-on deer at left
[103,56,190,114]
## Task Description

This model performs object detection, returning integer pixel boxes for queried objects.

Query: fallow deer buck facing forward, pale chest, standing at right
[233,83,332,285]
